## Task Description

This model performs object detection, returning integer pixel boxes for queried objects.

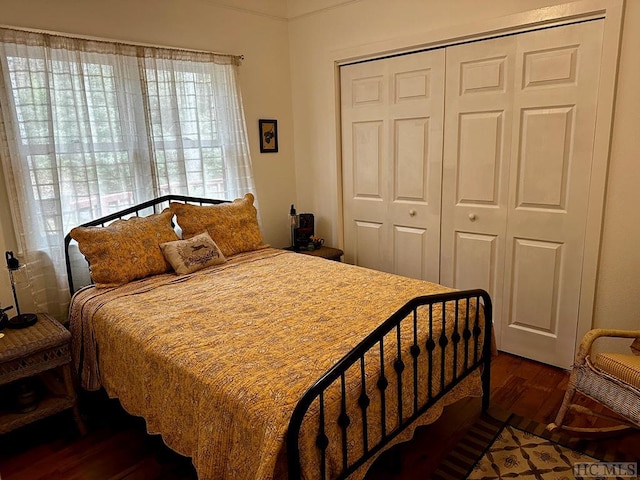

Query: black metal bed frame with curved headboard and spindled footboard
[65,195,492,480]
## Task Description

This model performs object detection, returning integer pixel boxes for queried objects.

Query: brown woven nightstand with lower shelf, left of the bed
[0,313,86,435]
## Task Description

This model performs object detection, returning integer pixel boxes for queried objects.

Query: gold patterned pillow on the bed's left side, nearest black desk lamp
[70,208,178,287]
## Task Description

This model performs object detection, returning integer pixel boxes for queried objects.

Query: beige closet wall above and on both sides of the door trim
[289,0,640,343]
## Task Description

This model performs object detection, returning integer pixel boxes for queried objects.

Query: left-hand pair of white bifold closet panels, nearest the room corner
[340,50,444,282]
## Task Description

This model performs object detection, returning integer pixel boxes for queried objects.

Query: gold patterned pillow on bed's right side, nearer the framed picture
[169,193,264,257]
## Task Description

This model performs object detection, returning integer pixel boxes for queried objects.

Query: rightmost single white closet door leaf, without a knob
[501,17,603,367]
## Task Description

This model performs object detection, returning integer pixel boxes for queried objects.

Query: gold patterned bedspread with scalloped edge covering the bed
[70,248,480,480]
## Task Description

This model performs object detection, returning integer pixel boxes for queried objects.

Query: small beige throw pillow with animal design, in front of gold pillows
[160,232,227,275]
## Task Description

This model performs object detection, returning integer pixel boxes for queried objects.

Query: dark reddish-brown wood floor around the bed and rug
[0,353,640,480]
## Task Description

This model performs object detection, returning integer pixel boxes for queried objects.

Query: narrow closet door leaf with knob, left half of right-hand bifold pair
[440,33,516,343]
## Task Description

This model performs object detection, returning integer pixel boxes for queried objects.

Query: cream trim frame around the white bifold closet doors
[326,0,624,349]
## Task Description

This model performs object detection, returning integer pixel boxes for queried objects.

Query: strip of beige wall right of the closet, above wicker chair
[594,0,640,343]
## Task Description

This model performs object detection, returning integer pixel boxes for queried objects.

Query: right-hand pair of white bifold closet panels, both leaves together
[442,21,602,367]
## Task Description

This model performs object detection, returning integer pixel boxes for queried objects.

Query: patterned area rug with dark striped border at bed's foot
[432,411,620,480]
